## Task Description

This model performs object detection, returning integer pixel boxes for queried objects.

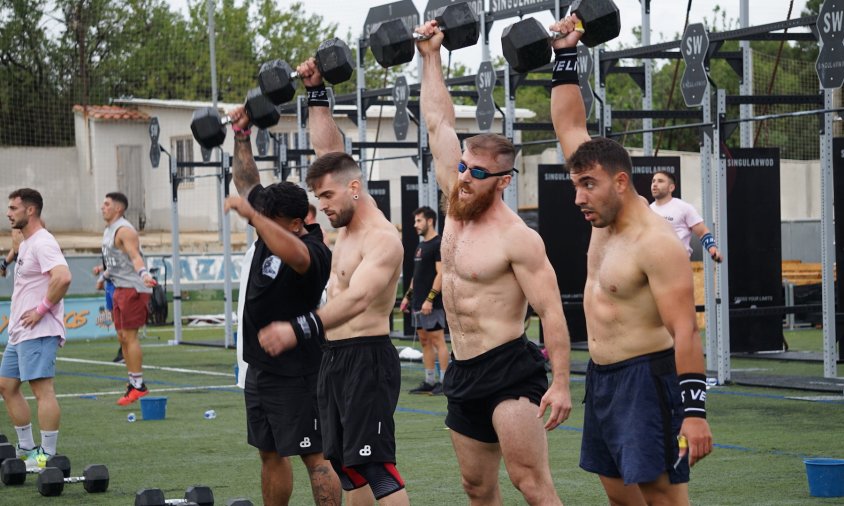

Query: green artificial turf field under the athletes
[0,327,844,506]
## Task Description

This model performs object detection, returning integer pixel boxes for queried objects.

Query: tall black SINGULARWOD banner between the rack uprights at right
[721,148,785,352]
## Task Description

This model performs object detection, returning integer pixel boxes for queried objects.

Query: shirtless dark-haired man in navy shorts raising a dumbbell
[551,16,712,504]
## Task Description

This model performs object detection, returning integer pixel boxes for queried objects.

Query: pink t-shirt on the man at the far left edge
[9,228,67,346]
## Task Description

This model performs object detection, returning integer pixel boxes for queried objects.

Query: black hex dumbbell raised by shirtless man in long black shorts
[258,37,354,105]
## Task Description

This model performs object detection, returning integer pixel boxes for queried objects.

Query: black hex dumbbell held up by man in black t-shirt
[190,88,281,149]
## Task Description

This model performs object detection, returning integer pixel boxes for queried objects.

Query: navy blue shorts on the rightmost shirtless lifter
[580,349,689,485]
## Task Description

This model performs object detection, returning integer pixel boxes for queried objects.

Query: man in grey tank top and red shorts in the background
[100,192,155,406]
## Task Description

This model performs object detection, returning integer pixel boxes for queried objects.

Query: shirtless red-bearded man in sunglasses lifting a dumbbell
[416,17,571,504]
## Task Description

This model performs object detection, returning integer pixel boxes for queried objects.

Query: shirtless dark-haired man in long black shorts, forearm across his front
[254,59,409,506]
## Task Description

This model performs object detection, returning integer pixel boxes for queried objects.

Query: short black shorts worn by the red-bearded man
[443,335,548,443]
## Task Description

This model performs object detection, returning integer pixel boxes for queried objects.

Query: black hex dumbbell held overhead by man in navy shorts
[501,0,621,73]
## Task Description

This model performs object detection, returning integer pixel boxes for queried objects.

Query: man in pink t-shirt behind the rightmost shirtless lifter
[651,171,722,262]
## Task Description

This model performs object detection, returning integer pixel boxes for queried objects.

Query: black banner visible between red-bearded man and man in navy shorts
[537,165,592,342]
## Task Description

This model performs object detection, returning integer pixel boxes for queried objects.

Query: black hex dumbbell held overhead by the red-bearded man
[369,2,481,68]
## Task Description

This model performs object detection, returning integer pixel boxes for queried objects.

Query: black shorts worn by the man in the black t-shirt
[244,366,322,457]
